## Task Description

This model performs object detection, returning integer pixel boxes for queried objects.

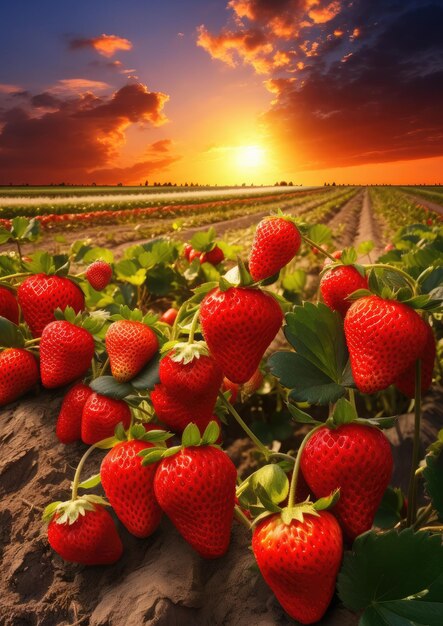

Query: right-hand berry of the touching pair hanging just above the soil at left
[82,393,131,445]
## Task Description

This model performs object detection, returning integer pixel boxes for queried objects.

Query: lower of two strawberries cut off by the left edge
[0,348,39,406]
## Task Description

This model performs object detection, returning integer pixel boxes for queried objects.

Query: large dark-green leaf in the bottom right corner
[338,528,443,626]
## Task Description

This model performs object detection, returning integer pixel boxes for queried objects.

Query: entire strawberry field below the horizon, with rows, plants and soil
[0,187,443,626]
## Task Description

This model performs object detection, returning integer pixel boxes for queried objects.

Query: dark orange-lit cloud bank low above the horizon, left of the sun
[0,83,177,184]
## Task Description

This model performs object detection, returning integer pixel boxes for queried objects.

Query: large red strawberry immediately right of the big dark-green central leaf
[344,296,427,393]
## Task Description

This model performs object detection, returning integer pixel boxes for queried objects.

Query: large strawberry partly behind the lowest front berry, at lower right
[301,424,392,541]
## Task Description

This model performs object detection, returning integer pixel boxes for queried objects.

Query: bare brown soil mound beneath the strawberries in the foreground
[0,390,442,626]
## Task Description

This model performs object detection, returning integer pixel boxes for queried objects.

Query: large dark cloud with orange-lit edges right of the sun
[197,0,443,170]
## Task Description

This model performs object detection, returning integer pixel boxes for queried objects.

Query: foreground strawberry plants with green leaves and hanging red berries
[0,197,443,626]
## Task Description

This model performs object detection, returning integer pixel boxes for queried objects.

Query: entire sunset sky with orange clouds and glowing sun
[0,0,443,185]
